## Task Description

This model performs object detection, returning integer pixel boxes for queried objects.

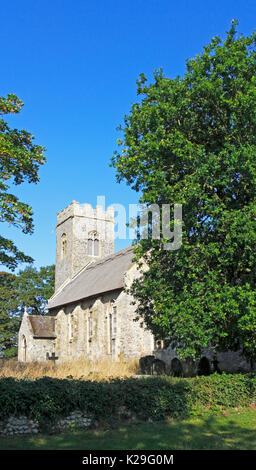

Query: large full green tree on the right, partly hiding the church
[112,21,256,361]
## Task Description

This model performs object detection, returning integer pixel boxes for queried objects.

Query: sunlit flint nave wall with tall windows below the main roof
[54,282,154,363]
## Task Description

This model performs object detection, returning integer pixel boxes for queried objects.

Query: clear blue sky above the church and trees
[0,0,256,268]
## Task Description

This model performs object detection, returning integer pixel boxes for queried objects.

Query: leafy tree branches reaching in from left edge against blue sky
[0,94,45,270]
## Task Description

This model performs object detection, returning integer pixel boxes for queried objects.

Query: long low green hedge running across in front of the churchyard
[0,374,256,426]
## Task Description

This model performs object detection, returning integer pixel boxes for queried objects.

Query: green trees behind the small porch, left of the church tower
[0,265,55,358]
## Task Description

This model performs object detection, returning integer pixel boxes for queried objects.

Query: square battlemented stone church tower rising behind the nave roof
[55,201,114,291]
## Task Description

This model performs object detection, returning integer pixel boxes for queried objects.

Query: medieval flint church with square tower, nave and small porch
[18,201,154,362]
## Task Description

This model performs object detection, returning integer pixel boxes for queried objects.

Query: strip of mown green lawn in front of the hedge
[0,409,256,450]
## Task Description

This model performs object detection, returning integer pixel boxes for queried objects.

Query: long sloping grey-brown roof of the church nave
[48,246,134,310]
